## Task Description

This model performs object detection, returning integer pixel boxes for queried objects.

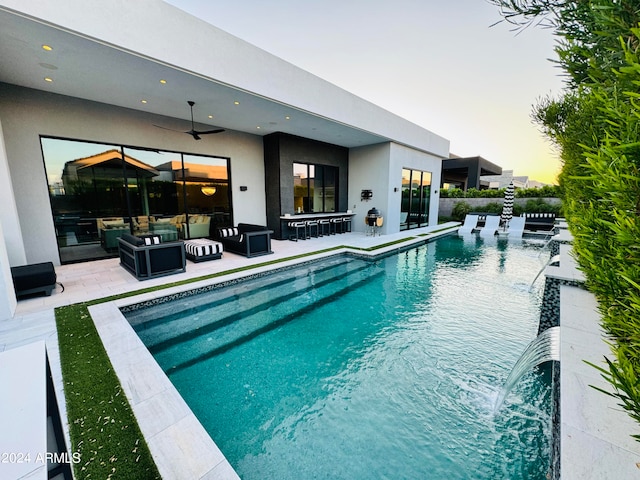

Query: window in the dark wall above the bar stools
[293,163,338,213]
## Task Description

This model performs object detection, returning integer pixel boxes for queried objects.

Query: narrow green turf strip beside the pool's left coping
[55,303,161,480]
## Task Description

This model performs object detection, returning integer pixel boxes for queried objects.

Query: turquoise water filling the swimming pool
[127,237,551,480]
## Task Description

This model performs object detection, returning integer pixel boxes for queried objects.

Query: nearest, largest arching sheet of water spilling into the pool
[494,327,560,412]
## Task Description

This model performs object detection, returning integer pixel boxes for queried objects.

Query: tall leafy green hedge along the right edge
[491,0,640,440]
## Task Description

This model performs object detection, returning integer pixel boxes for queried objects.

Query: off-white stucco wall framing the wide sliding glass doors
[0,84,266,265]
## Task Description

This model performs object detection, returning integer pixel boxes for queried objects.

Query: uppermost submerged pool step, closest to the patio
[127,257,367,352]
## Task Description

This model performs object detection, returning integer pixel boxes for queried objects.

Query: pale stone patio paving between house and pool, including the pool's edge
[0,222,459,480]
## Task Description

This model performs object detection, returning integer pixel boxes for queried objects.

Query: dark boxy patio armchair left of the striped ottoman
[118,233,187,280]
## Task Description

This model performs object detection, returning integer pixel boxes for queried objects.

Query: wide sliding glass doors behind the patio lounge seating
[41,137,232,263]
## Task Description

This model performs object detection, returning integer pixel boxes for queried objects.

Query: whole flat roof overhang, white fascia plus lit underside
[0,0,449,157]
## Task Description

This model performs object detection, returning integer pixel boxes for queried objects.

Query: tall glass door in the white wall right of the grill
[400,168,431,230]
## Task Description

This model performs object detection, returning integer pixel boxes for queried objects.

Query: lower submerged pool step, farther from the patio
[149,265,384,373]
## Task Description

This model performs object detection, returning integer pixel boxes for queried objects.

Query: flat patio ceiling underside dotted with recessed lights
[0,7,389,147]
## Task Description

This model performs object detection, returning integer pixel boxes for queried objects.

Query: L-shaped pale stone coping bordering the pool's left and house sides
[89,227,457,480]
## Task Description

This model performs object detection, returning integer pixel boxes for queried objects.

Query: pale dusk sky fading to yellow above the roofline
[166,0,562,183]
